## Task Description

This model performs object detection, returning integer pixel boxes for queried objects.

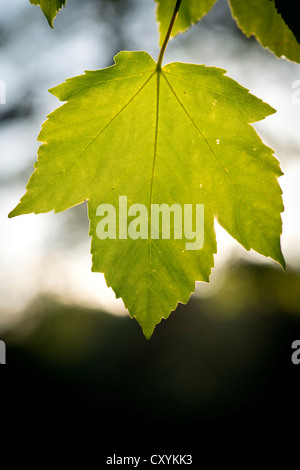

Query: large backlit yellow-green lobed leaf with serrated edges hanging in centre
[9,52,284,338]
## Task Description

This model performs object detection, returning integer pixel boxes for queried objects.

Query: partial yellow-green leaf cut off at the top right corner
[229,0,300,62]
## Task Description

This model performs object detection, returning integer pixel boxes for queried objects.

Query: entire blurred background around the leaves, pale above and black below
[0,0,300,468]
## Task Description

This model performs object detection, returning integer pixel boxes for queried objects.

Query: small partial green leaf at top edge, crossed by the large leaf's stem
[155,0,216,45]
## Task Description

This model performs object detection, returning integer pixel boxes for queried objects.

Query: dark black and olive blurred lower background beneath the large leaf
[1,263,300,468]
